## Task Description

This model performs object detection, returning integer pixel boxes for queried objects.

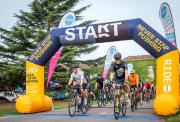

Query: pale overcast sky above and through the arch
[0,0,180,60]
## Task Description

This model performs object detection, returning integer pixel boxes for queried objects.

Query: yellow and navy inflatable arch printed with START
[16,19,180,115]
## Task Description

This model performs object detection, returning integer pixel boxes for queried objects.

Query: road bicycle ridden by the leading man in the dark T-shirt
[114,83,127,119]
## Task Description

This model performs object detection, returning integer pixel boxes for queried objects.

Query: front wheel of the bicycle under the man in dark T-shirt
[114,96,121,119]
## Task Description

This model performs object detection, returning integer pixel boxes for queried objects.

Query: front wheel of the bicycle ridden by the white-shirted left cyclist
[68,96,77,117]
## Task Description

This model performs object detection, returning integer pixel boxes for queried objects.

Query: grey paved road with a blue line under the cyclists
[0,103,164,122]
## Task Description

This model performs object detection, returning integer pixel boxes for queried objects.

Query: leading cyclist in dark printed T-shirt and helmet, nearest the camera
[110,52,129,102]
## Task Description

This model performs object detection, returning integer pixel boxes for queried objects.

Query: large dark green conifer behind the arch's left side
[0,0,97,91]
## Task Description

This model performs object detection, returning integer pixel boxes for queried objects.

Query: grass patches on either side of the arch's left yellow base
[0,101,68,116]
